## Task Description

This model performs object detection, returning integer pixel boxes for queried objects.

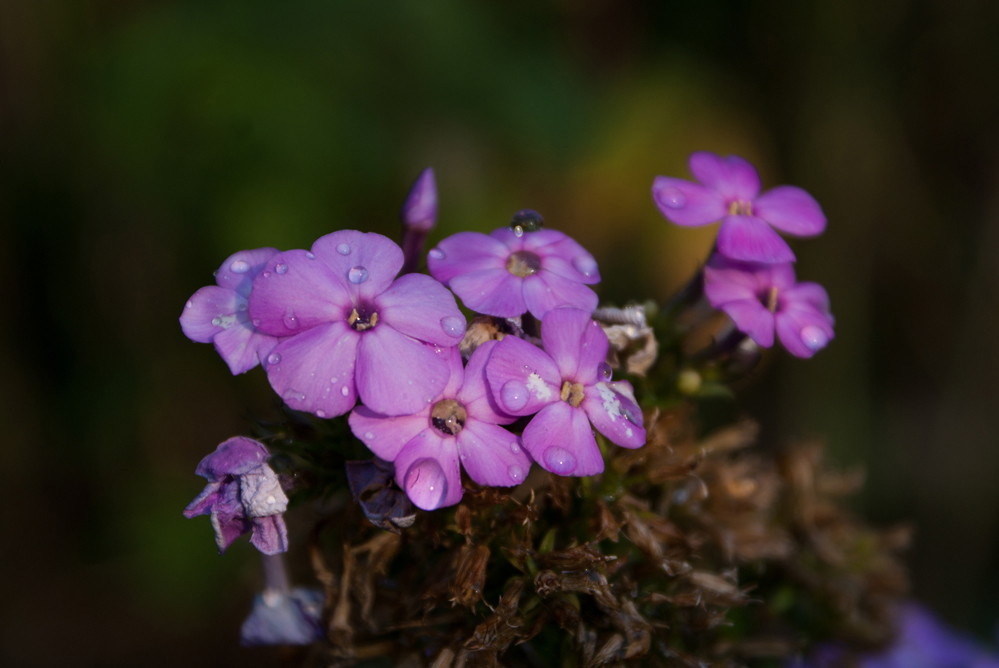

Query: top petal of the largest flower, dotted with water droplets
[312,230,404,304]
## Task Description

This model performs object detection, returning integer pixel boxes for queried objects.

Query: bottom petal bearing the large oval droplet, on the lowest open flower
[395,429,463,510]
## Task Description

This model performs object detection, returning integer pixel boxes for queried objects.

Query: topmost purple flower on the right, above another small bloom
[652,151,826,264]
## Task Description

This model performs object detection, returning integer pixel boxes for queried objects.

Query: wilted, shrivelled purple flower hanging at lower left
[184,436,288,554]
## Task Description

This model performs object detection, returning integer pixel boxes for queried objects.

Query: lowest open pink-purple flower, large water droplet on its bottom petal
[350,341,531,510]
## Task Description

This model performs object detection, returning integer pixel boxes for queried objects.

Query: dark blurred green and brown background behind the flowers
[0,0,999,666]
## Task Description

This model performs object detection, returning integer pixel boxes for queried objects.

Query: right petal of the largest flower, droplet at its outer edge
[374,274,465,346]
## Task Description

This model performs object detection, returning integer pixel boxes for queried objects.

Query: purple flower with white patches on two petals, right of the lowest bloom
[486,308,645,476]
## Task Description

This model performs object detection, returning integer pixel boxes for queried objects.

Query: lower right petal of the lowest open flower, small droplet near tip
[457,420,531,487]
